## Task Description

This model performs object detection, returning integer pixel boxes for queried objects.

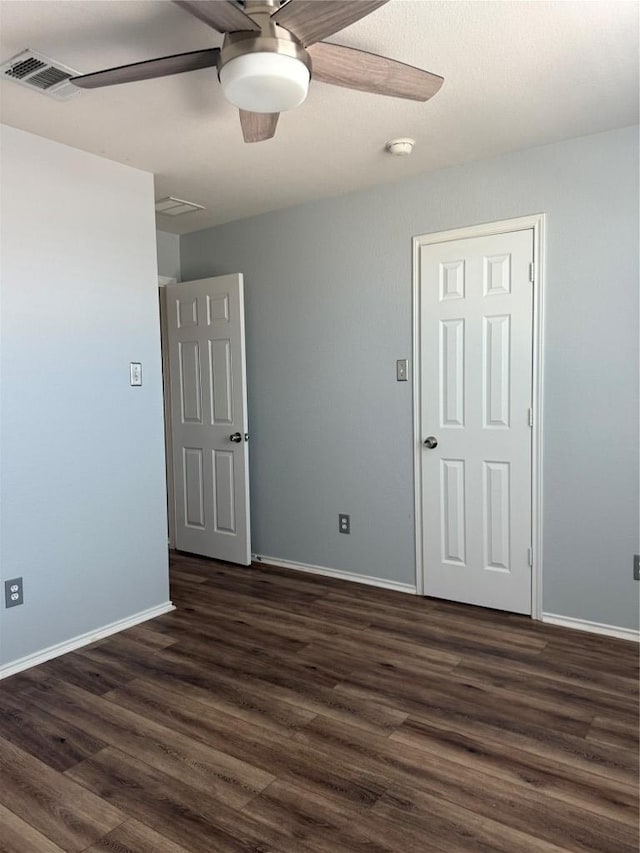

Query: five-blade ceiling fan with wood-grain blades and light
[71,0,444,142]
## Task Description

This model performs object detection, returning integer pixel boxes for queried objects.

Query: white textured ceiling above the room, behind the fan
[0,0,639,233]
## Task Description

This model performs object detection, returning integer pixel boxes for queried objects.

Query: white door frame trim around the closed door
[413,213,546,620]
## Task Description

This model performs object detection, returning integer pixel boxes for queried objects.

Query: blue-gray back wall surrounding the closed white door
[181,128,639,628]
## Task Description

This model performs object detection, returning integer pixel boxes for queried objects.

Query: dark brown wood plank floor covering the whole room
[0,556,638,853]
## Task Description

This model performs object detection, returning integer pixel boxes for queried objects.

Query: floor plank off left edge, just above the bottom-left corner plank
[0,738,125,853]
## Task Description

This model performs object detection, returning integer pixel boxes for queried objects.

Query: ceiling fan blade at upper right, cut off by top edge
[271,0,389,46]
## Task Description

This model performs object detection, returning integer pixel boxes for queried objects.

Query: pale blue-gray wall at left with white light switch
[0,127,169,664]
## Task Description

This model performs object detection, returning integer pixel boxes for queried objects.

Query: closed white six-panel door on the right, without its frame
[418,230,534,613]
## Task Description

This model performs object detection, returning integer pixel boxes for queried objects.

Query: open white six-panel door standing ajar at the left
[167,275,251,565]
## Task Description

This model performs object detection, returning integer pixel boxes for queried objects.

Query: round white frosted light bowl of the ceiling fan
[219,52,309,113]
